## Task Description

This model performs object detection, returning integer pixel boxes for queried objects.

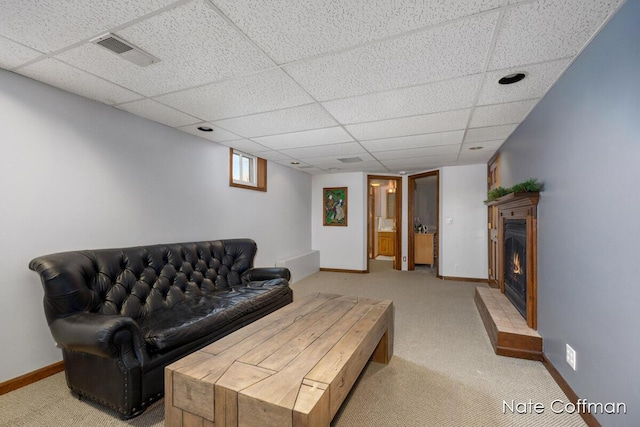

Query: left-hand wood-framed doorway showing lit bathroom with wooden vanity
[367,175,402,271]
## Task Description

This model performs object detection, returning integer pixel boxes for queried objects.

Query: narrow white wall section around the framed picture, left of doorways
[311,172,367,271]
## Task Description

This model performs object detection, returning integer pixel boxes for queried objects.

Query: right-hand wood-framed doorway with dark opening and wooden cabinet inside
[407,170,441,277]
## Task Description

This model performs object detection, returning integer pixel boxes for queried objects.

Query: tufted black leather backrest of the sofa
[29,239,257,324]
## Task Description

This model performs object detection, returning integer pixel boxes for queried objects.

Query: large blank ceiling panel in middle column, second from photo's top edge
[285,12,498,101]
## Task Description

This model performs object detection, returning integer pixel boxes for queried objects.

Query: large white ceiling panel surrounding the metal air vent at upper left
[58,1,273,96]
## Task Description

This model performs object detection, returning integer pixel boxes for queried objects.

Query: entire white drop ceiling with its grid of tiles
[0,0,624,174]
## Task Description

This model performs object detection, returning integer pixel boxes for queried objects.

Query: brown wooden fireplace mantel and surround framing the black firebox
[487,192,540,329]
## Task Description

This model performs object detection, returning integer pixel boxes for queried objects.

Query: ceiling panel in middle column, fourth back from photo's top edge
[345,109,471,141]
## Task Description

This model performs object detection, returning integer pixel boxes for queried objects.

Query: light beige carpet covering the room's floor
[0,261,586,427]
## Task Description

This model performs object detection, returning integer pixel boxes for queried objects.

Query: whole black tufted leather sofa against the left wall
[29,239,293,418]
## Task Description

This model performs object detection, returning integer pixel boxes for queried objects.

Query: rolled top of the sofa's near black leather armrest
[49,313,146,364]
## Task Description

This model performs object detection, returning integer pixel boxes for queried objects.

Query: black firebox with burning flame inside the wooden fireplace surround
[503,219,527,319]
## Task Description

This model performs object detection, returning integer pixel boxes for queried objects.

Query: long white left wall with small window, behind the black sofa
[0,70,310,382]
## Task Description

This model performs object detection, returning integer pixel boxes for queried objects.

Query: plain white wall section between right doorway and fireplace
[438,164,488,279]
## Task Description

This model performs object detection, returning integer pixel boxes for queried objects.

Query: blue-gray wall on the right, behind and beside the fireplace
[500,0,640,426]
